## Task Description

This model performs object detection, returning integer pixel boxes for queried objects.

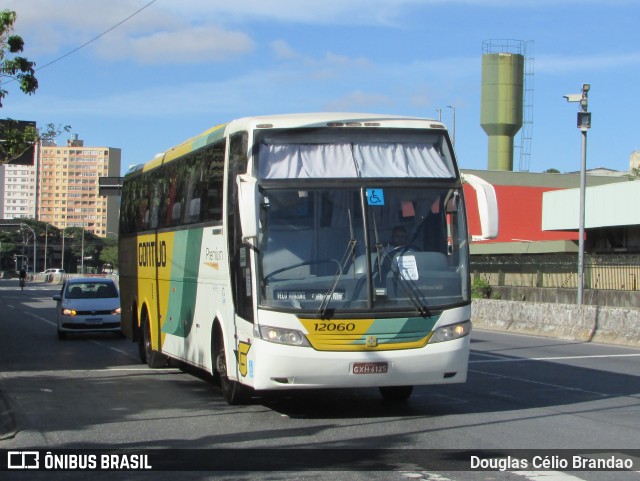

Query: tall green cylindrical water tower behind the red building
[480,41,525,170]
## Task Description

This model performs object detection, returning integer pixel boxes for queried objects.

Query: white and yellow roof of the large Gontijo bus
[127,112,445,175]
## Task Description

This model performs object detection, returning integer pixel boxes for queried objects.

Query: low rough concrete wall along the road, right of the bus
[471,299,640,347]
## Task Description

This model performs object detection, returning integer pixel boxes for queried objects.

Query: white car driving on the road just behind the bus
[53,277,120,339]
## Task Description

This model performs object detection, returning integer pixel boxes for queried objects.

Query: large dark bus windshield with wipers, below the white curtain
[259,185,469,317]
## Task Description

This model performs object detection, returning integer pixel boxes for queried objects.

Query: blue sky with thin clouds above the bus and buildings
[0,0,640,174]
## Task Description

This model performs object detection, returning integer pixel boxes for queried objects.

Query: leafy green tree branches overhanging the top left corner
[0,10,71,164]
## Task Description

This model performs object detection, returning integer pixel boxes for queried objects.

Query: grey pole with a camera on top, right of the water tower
[564,84,591,305]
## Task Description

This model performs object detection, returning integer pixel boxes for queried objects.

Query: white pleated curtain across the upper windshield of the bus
[259,143,453,179]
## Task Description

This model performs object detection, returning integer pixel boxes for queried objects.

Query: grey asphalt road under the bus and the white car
[0,280,640,481]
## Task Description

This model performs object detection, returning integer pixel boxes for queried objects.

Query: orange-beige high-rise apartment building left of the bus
[36,135,122,237]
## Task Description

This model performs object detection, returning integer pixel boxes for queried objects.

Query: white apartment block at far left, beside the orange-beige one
[0,164,36,219]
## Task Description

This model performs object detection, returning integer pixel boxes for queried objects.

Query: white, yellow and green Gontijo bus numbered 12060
[119,113,497,404]
